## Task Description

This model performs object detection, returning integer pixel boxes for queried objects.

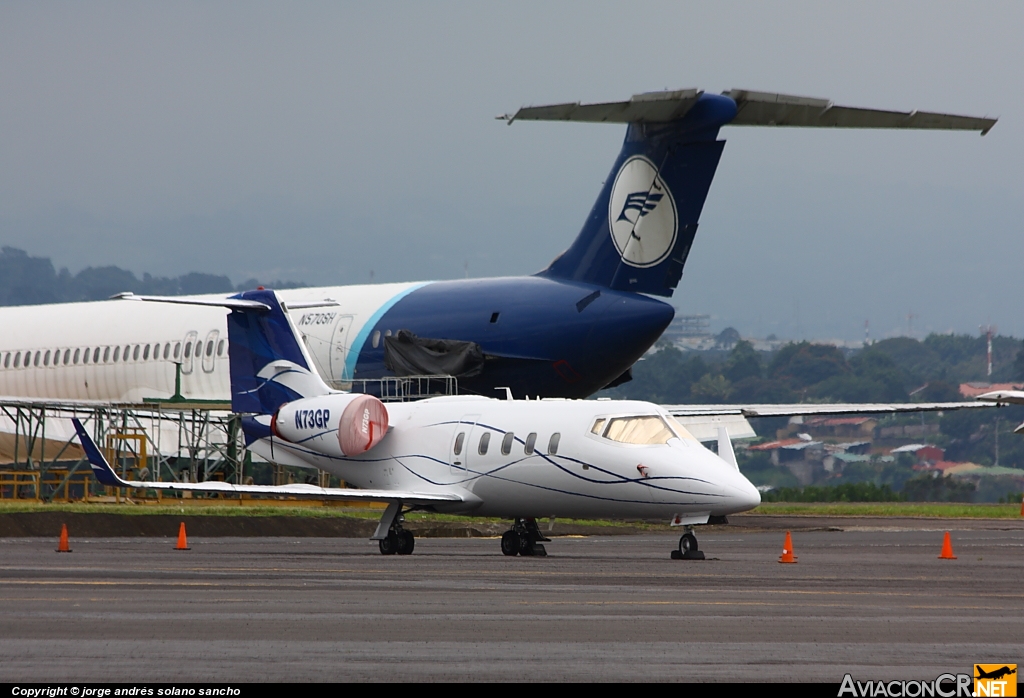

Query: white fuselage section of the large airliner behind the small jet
[0,283,423,402]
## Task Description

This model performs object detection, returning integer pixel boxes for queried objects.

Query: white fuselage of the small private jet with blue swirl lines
[260,395,760,518]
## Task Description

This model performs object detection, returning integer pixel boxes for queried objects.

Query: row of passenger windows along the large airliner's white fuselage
[0,340,224,368]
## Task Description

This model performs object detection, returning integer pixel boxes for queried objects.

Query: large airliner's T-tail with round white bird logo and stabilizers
[499,89,996,296]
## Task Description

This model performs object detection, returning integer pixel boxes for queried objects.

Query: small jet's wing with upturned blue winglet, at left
[72,419,463,505]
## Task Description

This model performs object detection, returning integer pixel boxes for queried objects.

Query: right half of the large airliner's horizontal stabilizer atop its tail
[722,90,996,135]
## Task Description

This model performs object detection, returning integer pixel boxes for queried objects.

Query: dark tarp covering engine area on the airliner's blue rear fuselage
[384,330,483,378]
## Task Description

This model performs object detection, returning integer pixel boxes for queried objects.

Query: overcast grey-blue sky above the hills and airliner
[0,0,1024,339]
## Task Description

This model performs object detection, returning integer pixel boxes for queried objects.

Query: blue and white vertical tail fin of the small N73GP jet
[227,291,331,415]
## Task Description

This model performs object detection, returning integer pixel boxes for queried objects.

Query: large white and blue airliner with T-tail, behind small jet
[0,90,995,402]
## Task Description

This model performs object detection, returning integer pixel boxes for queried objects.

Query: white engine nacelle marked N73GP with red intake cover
[270,393,388,455]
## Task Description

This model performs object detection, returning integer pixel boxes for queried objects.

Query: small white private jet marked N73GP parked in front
[74,291,761,558]
